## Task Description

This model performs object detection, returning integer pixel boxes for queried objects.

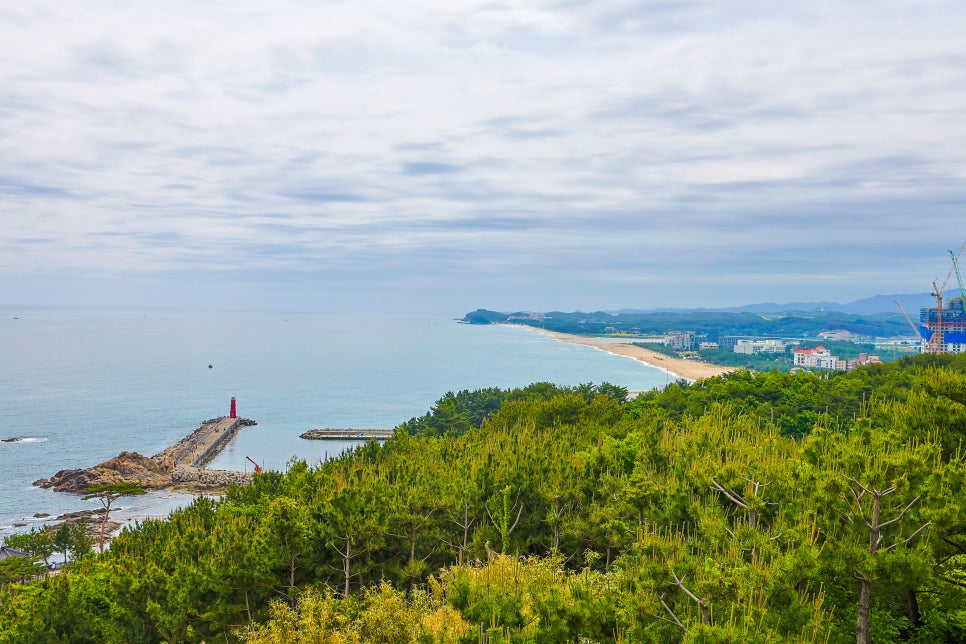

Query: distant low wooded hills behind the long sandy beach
[462,309,912,338]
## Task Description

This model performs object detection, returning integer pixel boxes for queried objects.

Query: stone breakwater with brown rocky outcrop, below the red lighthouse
[34,418,256,493]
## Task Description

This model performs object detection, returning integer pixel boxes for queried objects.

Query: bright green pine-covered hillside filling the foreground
[0,356,966,643]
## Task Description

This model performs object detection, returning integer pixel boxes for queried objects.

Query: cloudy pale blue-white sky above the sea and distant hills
[0,0,966,315]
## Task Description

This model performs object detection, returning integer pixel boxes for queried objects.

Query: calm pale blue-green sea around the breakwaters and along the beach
[0,309,668,537]
